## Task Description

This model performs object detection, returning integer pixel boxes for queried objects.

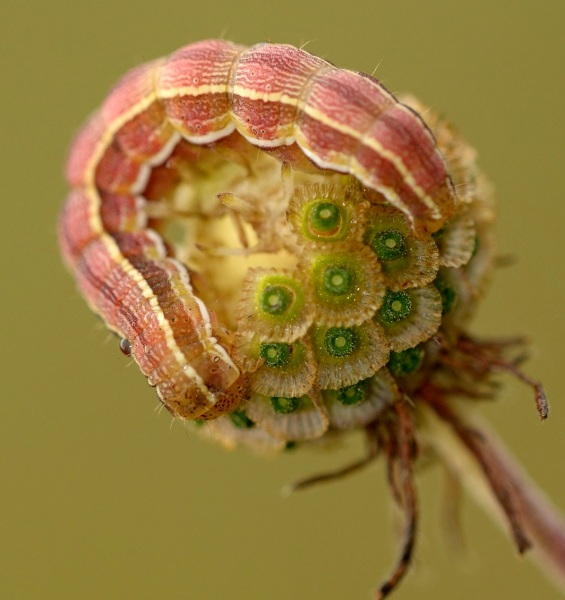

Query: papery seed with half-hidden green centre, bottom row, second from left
[247,392,329,441]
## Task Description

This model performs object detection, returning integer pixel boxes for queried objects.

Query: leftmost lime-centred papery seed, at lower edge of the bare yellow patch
[236,269,313,342]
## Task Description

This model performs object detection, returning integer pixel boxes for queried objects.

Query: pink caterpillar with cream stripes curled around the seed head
[60,41,456,418]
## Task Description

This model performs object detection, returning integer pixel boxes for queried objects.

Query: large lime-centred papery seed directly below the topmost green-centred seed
[306,244,385,327]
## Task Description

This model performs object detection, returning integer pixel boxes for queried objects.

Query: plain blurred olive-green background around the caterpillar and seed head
[0,0,565,600]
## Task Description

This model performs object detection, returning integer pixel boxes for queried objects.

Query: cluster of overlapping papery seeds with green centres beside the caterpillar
[209,132,494,449]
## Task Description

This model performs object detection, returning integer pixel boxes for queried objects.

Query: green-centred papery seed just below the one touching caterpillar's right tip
[375,285,442,352]
